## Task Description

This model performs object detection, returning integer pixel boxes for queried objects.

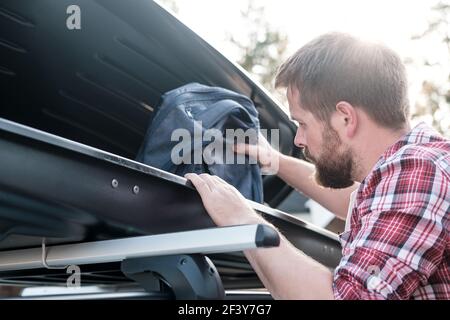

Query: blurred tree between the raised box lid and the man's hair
[228,0,288,98]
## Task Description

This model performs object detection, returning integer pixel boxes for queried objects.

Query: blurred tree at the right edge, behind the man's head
[412,0,450,137]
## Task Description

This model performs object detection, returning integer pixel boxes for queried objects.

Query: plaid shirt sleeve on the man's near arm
[333,159,449,299]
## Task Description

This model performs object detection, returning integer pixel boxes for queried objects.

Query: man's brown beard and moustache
[303,127,355,189]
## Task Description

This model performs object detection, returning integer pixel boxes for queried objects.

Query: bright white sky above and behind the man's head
[156,0,450,128]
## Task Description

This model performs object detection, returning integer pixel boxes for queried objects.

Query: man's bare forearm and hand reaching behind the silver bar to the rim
[186,174,334,299]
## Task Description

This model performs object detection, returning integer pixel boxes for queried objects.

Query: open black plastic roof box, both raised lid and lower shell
[0,0,340,288]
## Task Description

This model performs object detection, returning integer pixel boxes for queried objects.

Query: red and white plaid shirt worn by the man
[333,123,450,299]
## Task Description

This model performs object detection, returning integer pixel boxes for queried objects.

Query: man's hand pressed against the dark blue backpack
[234,133,281,175]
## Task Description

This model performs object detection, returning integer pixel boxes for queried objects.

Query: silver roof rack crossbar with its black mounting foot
[0,224,280,299]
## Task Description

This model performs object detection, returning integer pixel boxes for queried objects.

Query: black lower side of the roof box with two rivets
[0,117,214,249]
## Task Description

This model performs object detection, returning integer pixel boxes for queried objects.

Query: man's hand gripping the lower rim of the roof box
[185,173,261,227]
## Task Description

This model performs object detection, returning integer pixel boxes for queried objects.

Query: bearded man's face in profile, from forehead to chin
[287,88,355,189]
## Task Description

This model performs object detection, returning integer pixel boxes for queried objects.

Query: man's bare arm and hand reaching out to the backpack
[235,135,359,220]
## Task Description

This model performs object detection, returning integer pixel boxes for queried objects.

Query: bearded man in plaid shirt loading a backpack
[186,33,450,299]
